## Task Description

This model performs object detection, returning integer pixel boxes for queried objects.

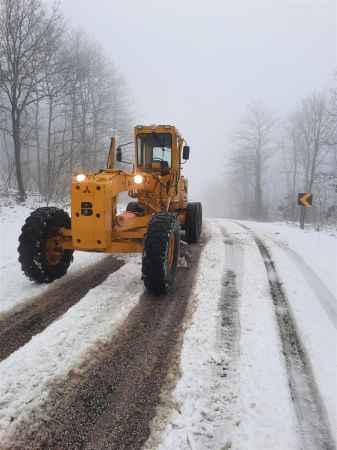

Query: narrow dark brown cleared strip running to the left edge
[0,256,124,361]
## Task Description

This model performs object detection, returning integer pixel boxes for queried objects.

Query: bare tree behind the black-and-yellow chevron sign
[284,92,336,225]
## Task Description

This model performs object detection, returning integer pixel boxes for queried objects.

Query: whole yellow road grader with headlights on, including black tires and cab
[18,125,202,294]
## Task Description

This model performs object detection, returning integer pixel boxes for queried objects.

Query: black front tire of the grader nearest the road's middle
[142,212,180,295]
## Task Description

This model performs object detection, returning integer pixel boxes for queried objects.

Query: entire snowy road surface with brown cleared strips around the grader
[0,202,337,450]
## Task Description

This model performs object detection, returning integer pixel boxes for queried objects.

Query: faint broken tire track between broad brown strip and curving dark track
[201,226,243,448]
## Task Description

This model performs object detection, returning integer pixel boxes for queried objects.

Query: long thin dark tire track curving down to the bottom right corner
[236,222,336,450]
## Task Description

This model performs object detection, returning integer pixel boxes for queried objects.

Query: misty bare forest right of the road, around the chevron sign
[220,88,337,226]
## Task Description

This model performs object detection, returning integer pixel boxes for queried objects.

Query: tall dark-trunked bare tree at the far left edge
[0,0,61,200]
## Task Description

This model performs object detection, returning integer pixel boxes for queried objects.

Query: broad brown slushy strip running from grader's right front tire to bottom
[6,239,202,450]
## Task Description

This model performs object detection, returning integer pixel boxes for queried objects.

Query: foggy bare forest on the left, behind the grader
[0,0,131,204]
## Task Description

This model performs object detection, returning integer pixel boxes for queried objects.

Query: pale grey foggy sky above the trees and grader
[54,0,337,200]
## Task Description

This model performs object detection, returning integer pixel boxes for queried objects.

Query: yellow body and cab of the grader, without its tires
[63,125,187,253]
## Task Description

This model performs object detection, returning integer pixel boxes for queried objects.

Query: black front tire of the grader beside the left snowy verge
[18,207,73,283]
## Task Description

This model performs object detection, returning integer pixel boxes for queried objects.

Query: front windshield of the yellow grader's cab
[137,133,172,170]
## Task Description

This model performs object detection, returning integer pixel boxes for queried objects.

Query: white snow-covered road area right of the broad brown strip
[148,220,337,450]
